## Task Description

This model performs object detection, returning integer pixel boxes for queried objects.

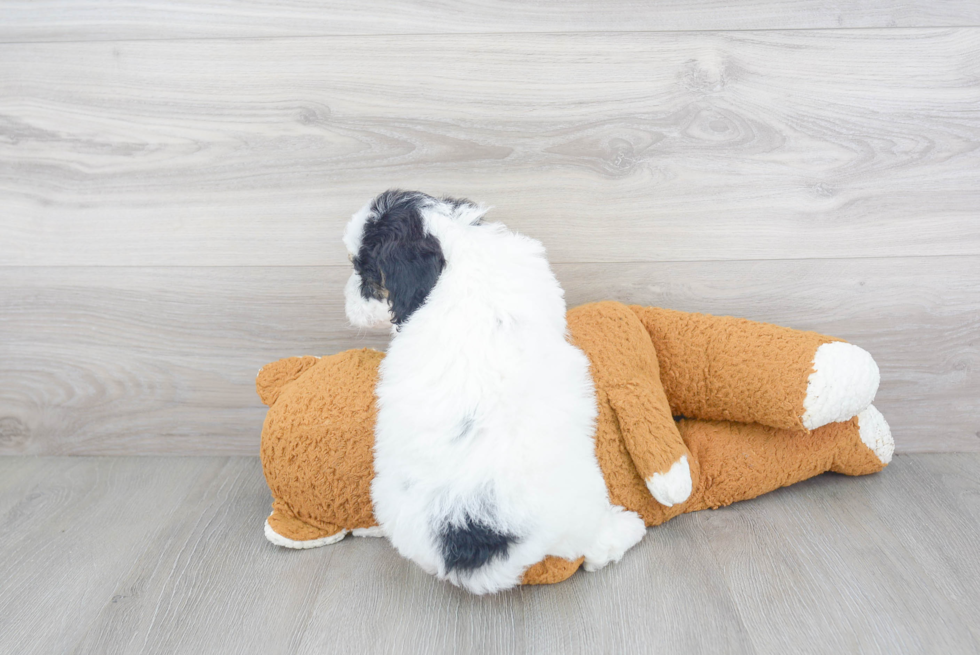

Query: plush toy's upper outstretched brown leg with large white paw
[630,305,880,431]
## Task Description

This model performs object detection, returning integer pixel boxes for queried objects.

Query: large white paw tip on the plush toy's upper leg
[801,341,881,430]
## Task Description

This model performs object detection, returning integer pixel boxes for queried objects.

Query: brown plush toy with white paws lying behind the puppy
[256,302,894,584]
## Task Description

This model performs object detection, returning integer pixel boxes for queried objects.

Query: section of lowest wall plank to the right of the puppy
[556,257,980,452]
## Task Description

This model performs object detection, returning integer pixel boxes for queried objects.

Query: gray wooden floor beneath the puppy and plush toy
[0,453,980,655]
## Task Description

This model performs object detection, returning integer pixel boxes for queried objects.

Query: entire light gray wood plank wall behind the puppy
[0,0,980,454]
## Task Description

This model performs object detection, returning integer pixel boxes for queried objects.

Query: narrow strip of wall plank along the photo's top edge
[0,0,980,41]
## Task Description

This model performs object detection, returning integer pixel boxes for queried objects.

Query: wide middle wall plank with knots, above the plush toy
[0,28,980,266]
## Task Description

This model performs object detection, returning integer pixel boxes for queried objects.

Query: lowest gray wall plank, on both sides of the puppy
[0,257,980,455]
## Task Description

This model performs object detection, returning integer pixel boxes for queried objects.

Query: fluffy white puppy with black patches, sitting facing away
[344,191,645,593]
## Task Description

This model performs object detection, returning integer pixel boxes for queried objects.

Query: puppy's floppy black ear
[376,234,446,325]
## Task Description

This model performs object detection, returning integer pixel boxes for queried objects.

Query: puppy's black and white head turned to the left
[344,190,482,328]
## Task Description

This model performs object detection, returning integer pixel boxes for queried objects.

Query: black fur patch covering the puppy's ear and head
[354,190,446,325]
